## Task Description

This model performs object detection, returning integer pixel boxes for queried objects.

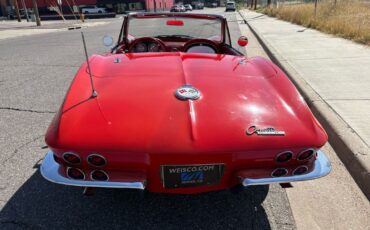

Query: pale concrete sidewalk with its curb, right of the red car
[240,10,370,199]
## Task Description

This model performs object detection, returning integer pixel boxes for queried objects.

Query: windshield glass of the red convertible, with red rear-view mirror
[128,17,222,42]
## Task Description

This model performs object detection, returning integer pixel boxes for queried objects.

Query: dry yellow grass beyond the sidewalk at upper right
[262,0,370,45]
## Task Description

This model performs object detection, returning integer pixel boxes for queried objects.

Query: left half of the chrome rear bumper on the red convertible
[40,150,145,190]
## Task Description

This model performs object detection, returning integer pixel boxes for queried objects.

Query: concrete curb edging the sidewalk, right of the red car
[238,11,370,200]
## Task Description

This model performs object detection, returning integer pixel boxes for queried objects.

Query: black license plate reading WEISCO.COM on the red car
[161,164,224,188]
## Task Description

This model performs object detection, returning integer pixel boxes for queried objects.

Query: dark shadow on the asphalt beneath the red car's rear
[0,171,270,229]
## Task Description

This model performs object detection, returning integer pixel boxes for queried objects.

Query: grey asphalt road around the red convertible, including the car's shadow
[0,8,295,229]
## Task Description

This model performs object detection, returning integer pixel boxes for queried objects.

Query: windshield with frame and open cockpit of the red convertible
[116,13,242,56]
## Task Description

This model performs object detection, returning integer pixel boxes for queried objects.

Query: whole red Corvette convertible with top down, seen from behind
[41,13,331,194]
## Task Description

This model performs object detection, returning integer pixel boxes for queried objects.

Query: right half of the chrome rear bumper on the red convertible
[241,150,331,186]
